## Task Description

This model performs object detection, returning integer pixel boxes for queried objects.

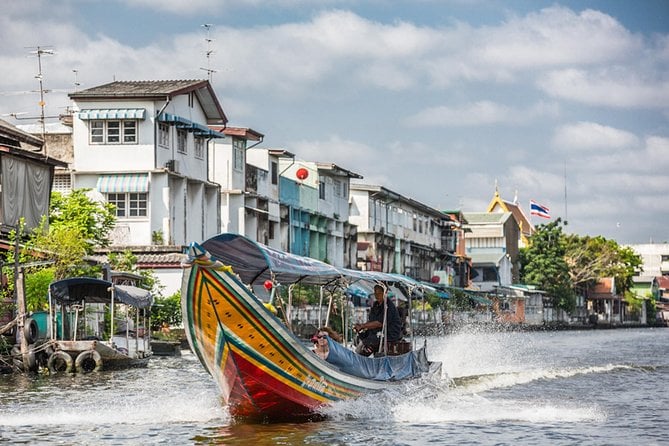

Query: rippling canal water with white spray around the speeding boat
[0,328,669,446]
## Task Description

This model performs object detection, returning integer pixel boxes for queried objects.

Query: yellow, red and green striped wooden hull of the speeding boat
[182,260,400,420]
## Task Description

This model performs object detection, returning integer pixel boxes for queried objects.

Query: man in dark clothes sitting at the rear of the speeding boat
[353,284,402,356]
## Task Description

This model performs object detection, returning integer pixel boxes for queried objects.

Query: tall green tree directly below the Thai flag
[520,218,576,312]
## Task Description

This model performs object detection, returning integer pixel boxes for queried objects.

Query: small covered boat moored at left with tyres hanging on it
[43,277,152,374]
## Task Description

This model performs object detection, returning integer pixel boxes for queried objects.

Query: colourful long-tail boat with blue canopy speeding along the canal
[182,234,441,421]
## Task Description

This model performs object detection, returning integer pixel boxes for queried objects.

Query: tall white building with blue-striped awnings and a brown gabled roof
[70,80,227,294]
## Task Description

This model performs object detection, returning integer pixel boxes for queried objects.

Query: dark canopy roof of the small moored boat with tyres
[49,277,153,308]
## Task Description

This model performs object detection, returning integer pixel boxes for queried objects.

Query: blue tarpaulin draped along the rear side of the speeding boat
[326,337,430,381]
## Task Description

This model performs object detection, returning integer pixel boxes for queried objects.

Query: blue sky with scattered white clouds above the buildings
[0,0,669,244]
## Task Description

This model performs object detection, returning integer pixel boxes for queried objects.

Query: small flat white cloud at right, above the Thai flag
[552,122,639,151]
